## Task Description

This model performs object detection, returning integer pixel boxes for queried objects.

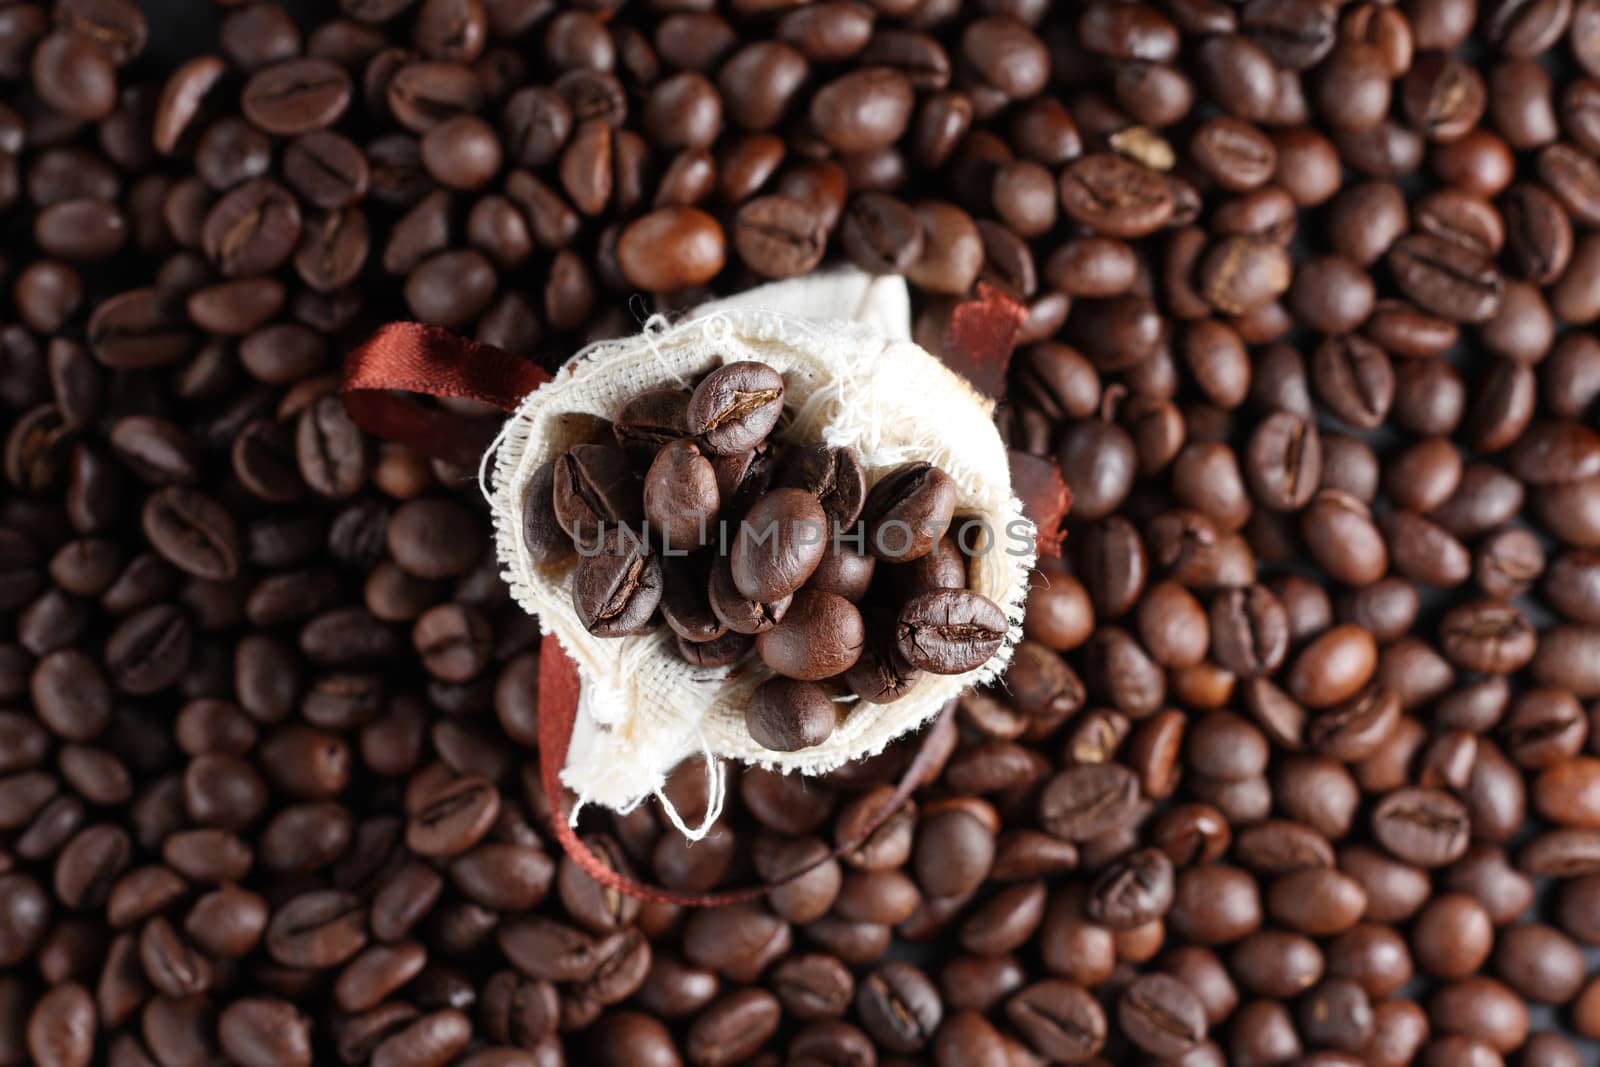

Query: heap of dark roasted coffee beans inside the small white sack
[523,360,1010,752]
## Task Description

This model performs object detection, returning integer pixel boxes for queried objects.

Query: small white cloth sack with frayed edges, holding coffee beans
[485,270,1034,838]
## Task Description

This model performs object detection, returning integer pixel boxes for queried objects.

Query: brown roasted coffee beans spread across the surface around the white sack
[9,0,1600,1067]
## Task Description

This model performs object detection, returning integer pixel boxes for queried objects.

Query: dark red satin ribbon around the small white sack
[339,295,1022,907]
